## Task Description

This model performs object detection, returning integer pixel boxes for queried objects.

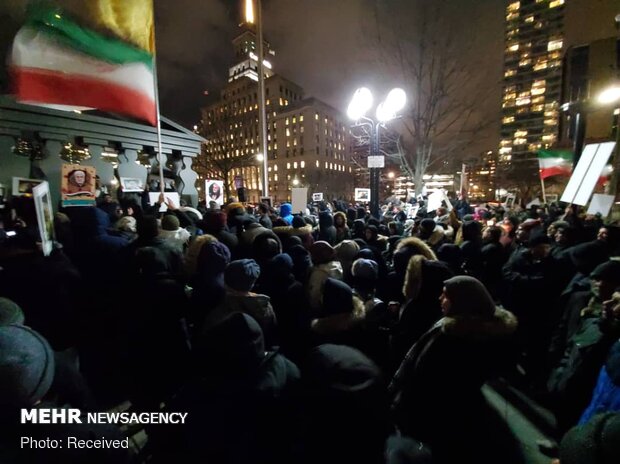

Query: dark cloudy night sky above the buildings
[0,0,505,148]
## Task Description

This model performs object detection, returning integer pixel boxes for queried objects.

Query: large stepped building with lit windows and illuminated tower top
[196,31,353,202]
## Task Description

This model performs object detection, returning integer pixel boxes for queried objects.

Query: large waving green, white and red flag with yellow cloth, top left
[10,0,157,125]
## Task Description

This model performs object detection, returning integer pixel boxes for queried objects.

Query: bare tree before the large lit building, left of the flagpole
[193,111,256,199]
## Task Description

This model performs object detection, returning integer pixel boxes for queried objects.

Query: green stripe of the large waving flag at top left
[26,7,153,67]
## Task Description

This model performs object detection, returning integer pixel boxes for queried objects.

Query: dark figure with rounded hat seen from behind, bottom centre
[290,344,392,464]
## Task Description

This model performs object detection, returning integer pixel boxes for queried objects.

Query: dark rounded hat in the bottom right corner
[560,412,620,464]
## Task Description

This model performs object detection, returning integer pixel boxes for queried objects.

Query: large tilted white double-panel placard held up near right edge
[560,142,616,206]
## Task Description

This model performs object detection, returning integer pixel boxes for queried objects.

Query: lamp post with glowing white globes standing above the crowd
[347,87,407,218]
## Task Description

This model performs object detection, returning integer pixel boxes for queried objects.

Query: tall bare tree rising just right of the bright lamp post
[375,0,499,194]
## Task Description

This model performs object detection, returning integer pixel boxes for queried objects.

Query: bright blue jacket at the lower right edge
[579,341,620,424]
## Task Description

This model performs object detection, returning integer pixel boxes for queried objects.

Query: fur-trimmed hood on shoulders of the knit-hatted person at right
[438,307,518,341]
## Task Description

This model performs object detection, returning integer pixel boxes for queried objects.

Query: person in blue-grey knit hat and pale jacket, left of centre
[203,259,277,347]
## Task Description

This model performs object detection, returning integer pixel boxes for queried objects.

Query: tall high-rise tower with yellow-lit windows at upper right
[499,0,565,177]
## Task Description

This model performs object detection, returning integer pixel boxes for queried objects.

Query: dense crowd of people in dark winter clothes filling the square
[0,189,620,464]
